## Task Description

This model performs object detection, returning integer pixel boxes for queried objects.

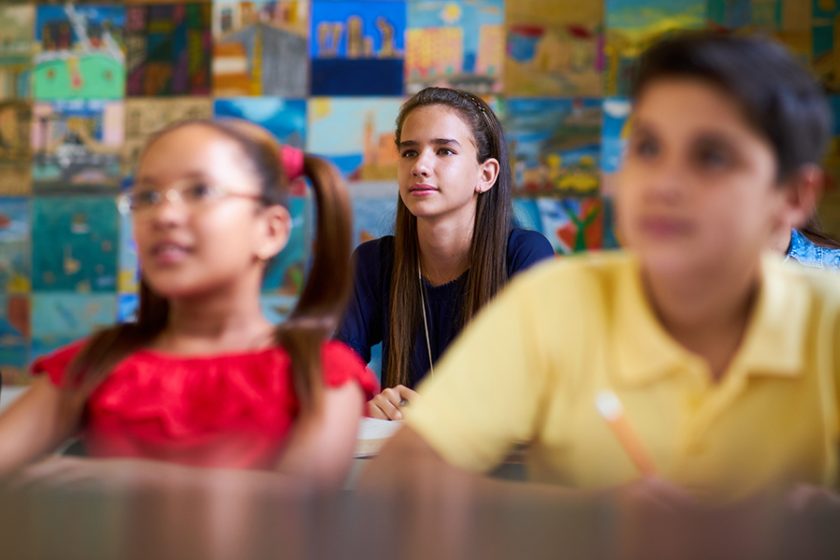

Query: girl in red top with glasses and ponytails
[0,120,377,487]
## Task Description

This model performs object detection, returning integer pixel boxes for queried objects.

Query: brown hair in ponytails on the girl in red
[68,119,352,410]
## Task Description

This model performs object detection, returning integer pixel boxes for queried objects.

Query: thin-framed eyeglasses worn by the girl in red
[117,179,266,214]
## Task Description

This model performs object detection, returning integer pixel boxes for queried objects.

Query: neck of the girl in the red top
[155,280,273,354]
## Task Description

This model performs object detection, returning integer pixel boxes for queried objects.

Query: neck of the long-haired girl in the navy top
[417,214,473,285]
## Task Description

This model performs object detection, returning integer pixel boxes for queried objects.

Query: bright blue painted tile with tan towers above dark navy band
[310,0,406,95]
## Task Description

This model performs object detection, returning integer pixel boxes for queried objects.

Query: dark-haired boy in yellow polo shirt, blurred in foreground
[369,31,840,504]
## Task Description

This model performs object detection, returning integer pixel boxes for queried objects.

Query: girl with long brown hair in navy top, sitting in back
[336,87,553,420]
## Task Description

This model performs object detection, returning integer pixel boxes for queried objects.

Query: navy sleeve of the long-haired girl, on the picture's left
[334,239,387,364]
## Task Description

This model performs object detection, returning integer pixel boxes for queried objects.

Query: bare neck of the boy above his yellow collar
[643,266,760,381]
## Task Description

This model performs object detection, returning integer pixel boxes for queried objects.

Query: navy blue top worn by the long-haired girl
[335,229,554,387]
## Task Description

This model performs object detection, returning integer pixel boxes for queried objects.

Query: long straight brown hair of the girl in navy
[383,87,513,387]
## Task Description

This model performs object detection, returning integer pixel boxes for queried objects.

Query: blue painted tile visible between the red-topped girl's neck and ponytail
[262,196,312,296]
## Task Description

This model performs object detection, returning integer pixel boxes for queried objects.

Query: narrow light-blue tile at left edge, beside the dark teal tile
[0,197,32,293]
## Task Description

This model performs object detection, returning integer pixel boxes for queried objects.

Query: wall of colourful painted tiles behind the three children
[0,0,840,383]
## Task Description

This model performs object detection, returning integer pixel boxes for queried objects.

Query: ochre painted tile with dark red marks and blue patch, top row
[504,0,604,97]
